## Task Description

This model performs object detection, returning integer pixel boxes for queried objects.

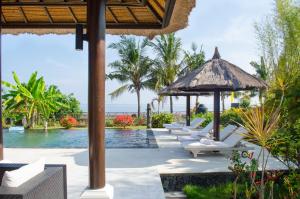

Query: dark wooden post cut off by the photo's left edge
[0,0,3,160]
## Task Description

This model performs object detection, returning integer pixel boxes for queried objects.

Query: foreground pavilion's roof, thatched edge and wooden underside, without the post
[1,0,196,37]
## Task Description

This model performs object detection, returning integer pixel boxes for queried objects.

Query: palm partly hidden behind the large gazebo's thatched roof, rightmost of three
[180,42,205,109]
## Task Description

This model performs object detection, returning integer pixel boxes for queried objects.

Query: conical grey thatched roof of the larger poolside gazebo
[168,48,267,92]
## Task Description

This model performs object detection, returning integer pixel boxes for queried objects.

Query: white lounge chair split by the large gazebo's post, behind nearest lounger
[178,123,238,142]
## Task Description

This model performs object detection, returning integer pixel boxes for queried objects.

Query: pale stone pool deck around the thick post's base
[4,129,284,199]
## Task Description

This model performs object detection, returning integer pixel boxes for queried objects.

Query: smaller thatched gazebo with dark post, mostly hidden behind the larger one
[158,87,210,126]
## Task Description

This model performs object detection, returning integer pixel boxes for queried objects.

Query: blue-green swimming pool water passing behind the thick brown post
[4,129,157,148]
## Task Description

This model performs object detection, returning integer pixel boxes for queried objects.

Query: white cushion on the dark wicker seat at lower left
[1,158,45,187]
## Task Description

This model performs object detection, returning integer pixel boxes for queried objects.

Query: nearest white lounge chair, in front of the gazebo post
[183,127,253,158]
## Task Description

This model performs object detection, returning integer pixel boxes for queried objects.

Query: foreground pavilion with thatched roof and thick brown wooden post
[0,0,196,198]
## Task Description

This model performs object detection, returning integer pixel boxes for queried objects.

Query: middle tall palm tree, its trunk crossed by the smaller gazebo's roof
[150,33,181,113]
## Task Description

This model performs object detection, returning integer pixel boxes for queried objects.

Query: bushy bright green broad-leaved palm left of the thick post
[2,72,65,128]
